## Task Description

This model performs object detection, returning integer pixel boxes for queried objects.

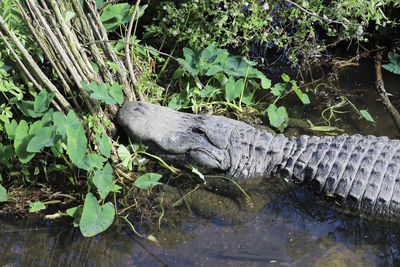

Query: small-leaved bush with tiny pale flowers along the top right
[145,0,400,66]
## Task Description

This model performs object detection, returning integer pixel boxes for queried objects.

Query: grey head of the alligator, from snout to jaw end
[118,102,250,172]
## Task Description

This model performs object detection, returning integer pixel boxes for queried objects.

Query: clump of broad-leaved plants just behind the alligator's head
[168,43,271,109]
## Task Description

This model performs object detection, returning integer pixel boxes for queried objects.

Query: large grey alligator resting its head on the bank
[117,101,400,217]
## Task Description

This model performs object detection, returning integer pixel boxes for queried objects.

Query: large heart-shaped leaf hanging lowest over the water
[79,193,115,237]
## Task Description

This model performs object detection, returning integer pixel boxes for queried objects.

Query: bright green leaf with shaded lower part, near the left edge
[14,120,35,163]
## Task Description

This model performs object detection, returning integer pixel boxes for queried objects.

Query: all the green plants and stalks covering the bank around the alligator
[0,0,400,236]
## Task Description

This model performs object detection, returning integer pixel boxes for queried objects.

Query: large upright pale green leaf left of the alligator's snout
[66,125,87,167]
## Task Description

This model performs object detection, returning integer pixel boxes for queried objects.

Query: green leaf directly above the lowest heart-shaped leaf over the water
[93,163,121,199]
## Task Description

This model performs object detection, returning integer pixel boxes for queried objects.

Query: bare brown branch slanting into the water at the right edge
[375,51,400,130]
